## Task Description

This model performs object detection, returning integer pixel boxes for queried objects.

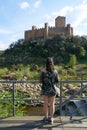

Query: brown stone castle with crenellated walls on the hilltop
[24,16,73,41]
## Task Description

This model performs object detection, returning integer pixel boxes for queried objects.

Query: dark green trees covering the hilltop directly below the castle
[0,35,87,65]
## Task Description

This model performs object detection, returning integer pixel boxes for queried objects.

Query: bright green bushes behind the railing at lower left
[0,86,27,117]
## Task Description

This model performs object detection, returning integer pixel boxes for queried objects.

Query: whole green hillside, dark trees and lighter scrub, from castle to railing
[0,35,87,79]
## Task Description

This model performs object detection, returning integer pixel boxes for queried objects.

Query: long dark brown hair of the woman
[46,57,54,72]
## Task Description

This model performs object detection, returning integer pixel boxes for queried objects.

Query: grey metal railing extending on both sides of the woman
[0,80,87,116]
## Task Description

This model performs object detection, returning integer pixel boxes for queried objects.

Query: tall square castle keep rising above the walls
[55,16,66,27]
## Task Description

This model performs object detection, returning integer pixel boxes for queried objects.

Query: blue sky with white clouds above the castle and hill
[0,0,87,50]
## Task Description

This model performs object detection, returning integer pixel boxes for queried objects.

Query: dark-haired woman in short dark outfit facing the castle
[41,57,59,124]
